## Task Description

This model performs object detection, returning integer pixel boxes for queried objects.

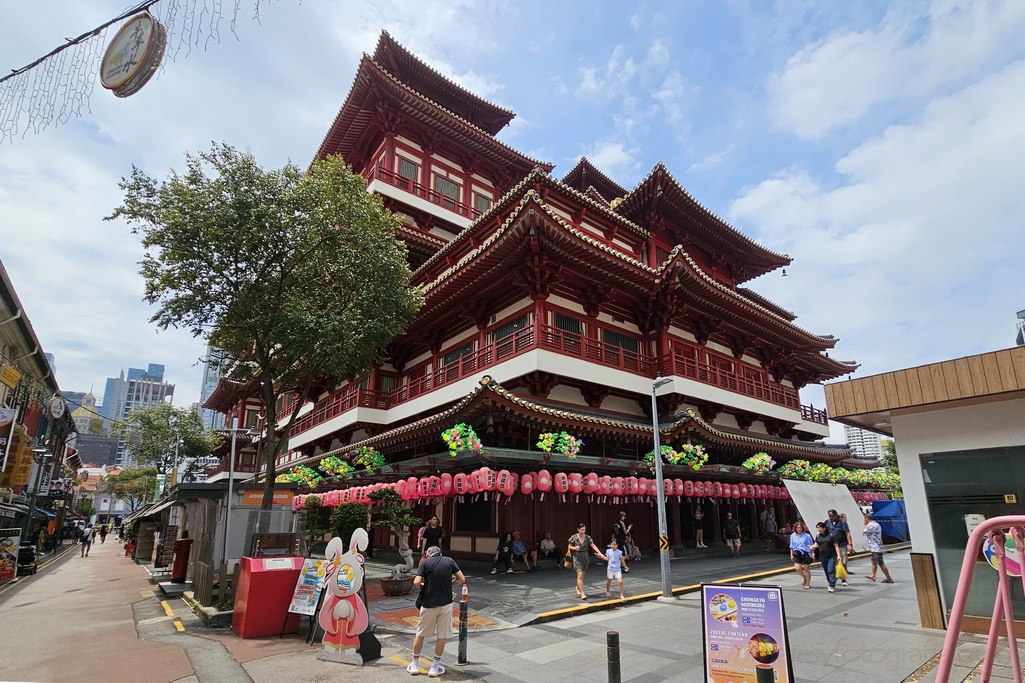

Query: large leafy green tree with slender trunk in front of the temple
[109,144,422,516]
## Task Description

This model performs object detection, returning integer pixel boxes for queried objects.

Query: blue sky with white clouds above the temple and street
[0,0,1025,440]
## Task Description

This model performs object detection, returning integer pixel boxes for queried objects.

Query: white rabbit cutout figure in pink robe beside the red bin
[317,529,369,667]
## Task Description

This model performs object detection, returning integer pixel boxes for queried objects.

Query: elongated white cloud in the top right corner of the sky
[769,0,1025,138]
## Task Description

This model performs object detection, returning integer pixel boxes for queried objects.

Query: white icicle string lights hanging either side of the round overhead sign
[0,0,269,145]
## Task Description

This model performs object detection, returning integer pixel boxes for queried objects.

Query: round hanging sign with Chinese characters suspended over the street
[99,12,167,97]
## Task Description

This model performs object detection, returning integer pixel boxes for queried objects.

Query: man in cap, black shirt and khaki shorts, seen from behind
[406,546,466,678]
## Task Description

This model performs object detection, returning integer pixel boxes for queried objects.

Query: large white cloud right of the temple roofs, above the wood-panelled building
[731,61,1025,373]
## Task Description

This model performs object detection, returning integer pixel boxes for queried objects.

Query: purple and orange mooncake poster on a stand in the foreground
[701,585,793,683]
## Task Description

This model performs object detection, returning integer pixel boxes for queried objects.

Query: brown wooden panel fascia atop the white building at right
[825,347,1025,417]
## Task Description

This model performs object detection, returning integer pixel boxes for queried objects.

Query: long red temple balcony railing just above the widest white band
[289,325,827,437]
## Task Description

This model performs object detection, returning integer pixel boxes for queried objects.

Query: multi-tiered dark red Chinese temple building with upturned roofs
[205,33,871,557]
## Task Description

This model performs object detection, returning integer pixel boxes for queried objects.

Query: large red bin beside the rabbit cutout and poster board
[232,557,303,638]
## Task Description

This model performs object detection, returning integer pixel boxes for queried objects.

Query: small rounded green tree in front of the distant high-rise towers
[111,403,221,474]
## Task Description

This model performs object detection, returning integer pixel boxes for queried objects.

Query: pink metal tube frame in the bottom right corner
[936,515,1025,683]
